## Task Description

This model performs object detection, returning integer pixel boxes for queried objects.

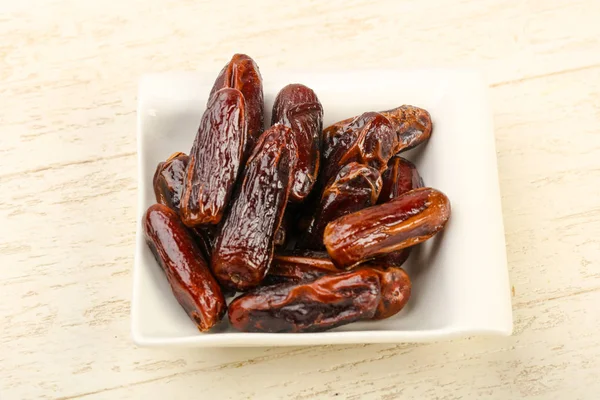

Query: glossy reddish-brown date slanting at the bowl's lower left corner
[143,204,227,332]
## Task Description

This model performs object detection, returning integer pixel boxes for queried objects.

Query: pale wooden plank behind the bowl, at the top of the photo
[0,0,600,174]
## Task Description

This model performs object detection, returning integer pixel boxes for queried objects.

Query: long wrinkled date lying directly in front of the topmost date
[180,88,247,227]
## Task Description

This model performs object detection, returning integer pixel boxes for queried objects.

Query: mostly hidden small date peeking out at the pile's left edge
[152,152,190,213]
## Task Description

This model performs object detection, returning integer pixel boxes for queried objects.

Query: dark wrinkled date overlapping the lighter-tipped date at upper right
[321,112,399,183]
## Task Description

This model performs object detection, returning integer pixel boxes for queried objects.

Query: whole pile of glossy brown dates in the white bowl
[143,54,450,332]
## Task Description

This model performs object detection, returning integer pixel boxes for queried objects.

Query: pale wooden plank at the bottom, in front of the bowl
[50,292,600,400]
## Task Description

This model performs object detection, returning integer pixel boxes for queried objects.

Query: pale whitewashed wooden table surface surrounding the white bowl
[0,0,600,400]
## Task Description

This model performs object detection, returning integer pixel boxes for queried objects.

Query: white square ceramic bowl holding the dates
[131,70,512,347]
